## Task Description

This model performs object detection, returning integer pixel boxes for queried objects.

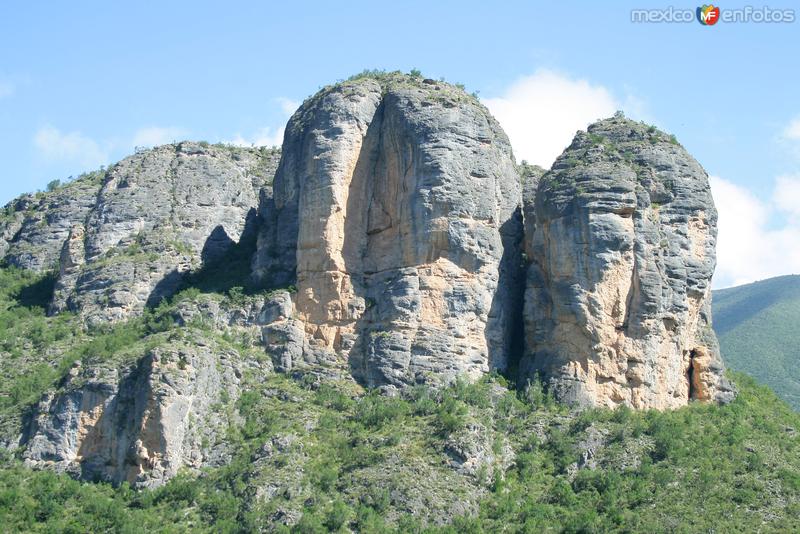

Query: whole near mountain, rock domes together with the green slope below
[0,72,800,533]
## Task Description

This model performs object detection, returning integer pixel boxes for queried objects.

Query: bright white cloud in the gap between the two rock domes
[481,69,620,168]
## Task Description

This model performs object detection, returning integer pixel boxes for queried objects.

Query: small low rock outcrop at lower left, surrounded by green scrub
[25,332,243,487]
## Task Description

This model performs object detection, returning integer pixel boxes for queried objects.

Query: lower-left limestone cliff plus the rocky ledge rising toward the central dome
[22,293,286,487]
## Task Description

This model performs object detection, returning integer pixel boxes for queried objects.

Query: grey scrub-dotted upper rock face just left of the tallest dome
[50,142,278,324]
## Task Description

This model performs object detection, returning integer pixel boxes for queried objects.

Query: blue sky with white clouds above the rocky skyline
[0,0,800,287]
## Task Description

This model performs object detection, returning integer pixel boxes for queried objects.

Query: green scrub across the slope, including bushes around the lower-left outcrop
[0,267,800,533]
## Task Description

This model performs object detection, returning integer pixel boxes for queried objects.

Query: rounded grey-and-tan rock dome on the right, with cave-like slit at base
[522,115,733,409]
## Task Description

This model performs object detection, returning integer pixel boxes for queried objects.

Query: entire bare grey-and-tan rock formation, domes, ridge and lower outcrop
[0,74,733,492]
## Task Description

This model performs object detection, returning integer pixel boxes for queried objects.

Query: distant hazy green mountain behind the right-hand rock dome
[713,275,800,409]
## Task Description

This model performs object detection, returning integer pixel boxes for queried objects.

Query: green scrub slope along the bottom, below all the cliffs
[0,364,800,533]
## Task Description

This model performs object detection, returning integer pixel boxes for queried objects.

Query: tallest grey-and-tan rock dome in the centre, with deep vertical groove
[254,76,522,386]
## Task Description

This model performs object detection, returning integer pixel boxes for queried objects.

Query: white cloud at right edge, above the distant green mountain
[710,176,800,287]
